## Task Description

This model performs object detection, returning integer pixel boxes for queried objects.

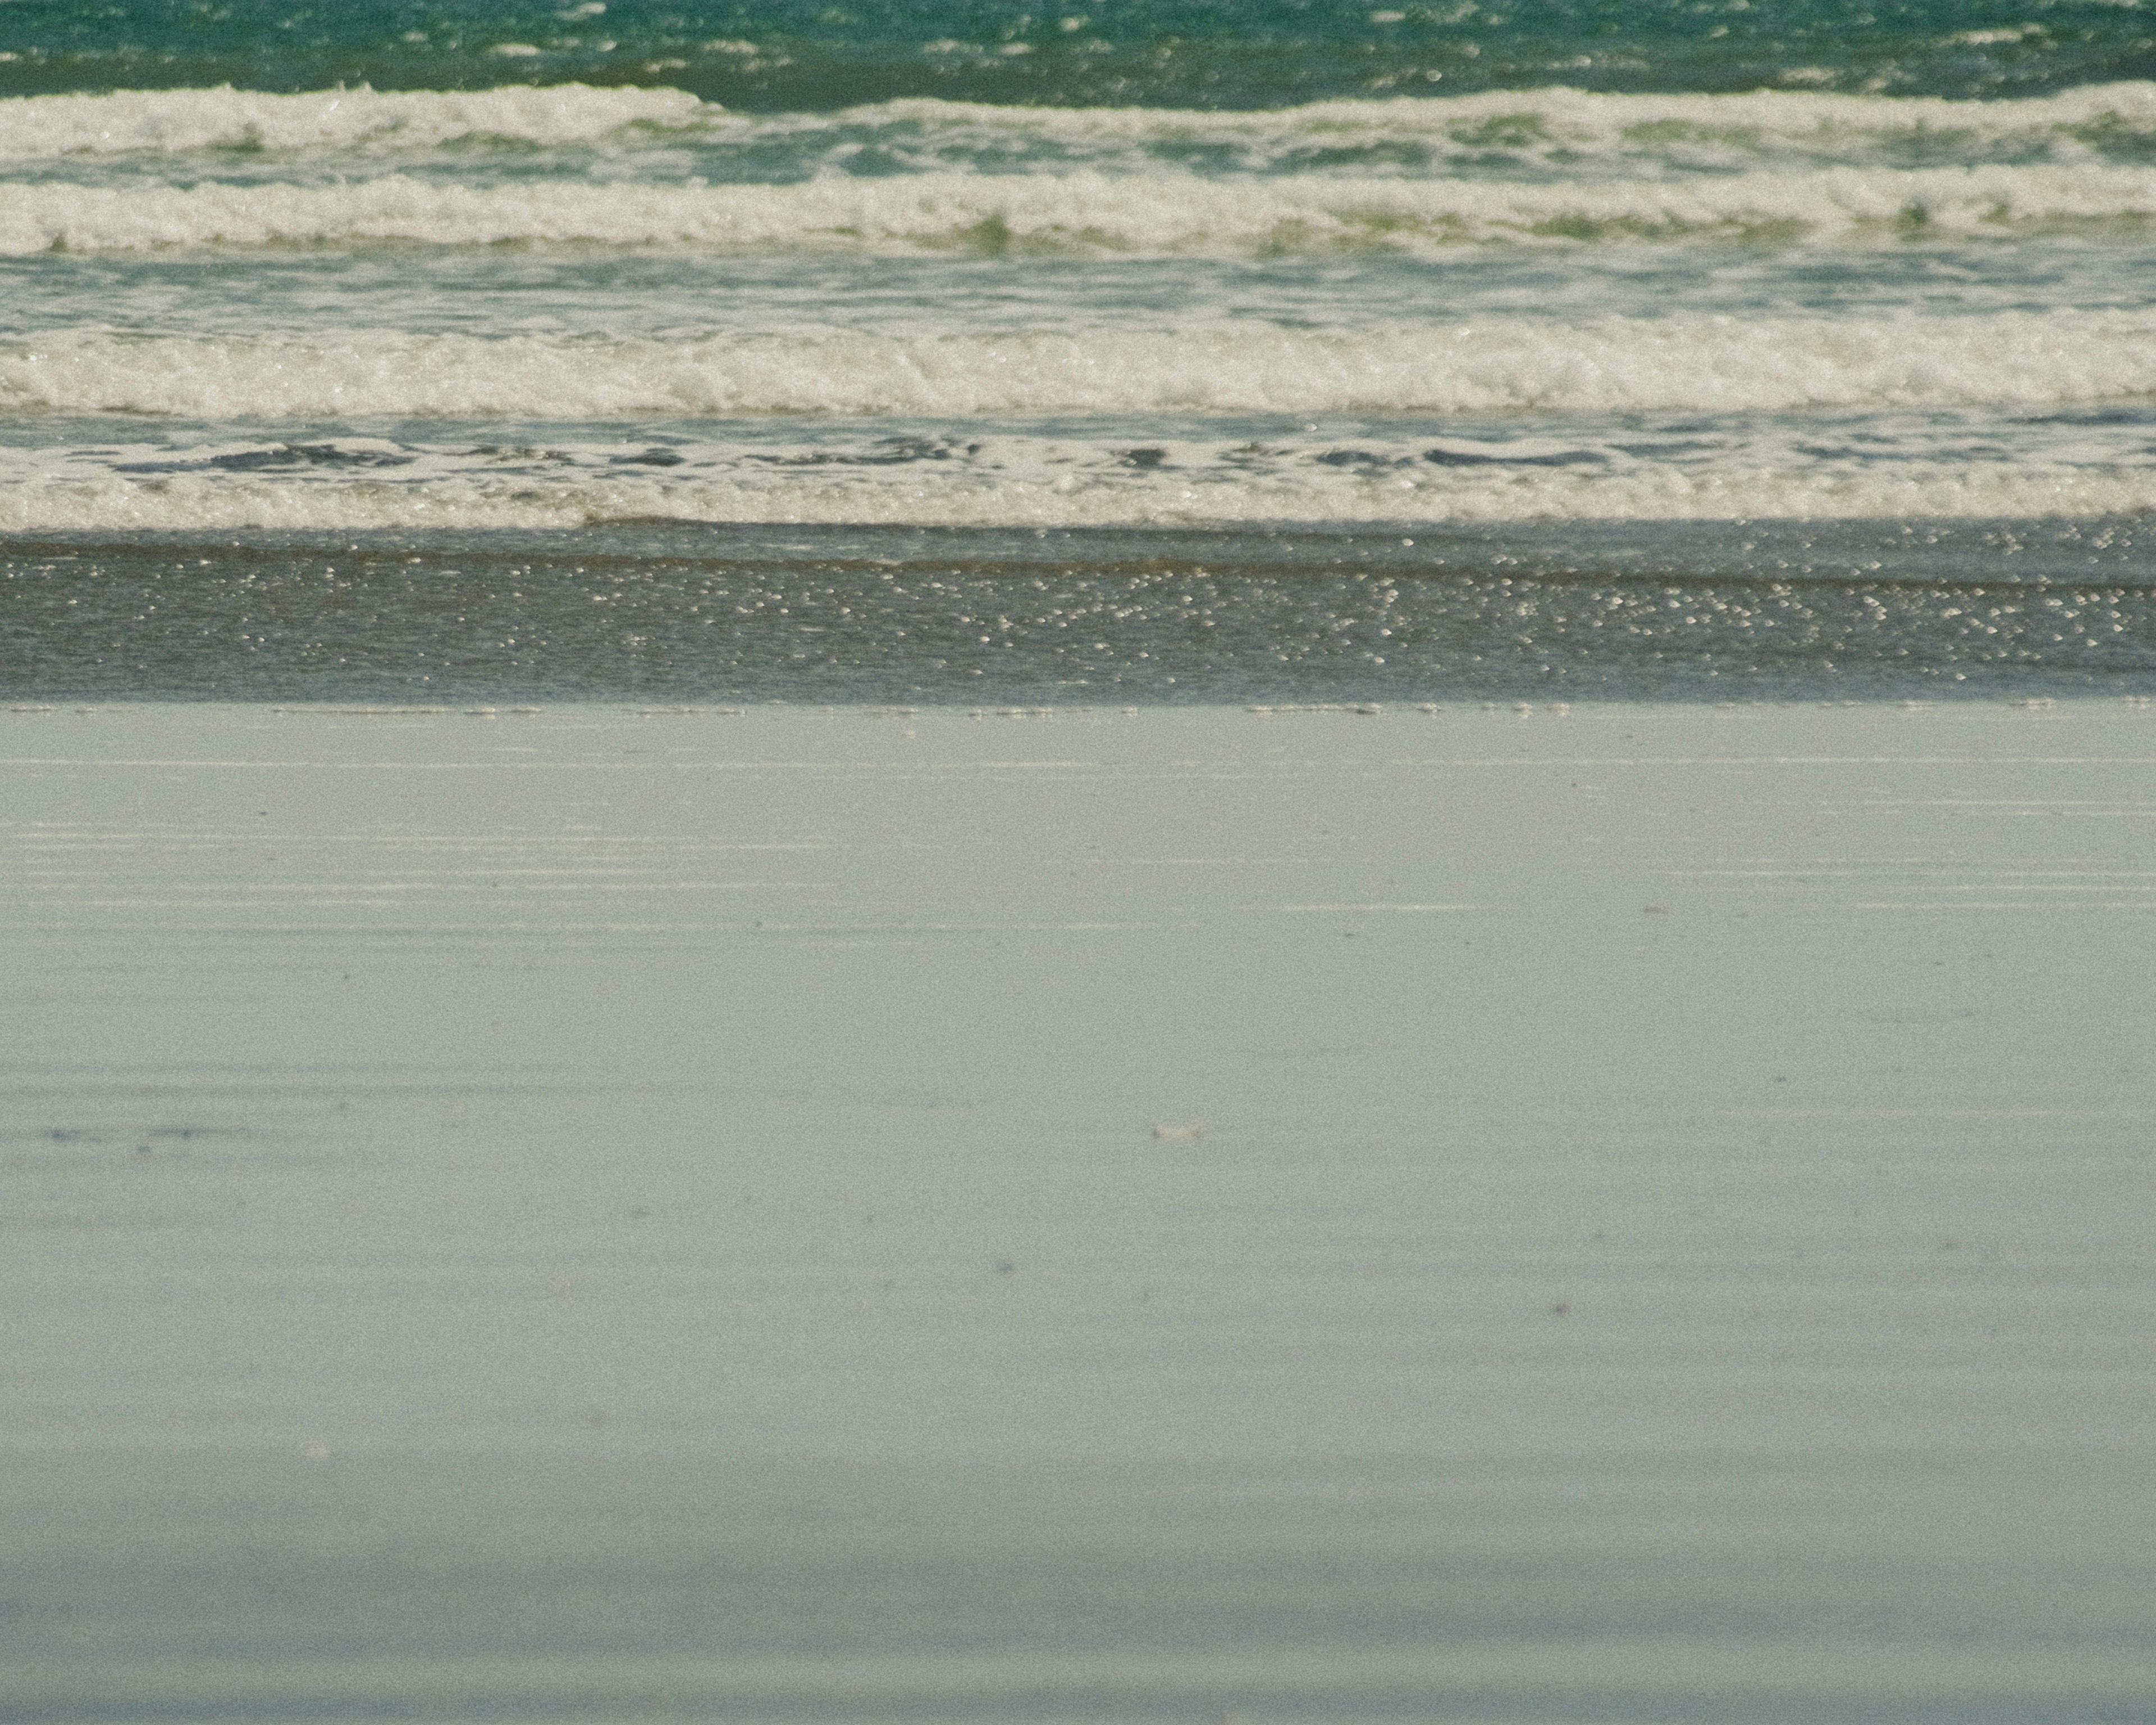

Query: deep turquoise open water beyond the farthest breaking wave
[12,0,2156,112]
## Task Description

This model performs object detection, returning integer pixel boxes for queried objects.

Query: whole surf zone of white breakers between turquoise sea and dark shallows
[0,84,2156,531]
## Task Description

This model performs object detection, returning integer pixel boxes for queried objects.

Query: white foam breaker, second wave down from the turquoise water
[17,166,2156,257]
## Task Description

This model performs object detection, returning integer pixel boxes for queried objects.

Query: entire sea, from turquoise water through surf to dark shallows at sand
[12,0,2156,701]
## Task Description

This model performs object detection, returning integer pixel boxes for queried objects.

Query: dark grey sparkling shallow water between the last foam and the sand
[0,518,2156,705]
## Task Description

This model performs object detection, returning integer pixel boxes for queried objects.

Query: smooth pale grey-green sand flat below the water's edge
[0,703,2156,1725]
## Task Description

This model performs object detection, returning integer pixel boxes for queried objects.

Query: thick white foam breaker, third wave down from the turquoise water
[0,308,2156,423]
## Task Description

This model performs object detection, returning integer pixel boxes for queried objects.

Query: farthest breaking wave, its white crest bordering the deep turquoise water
[12,82,2156,177]
